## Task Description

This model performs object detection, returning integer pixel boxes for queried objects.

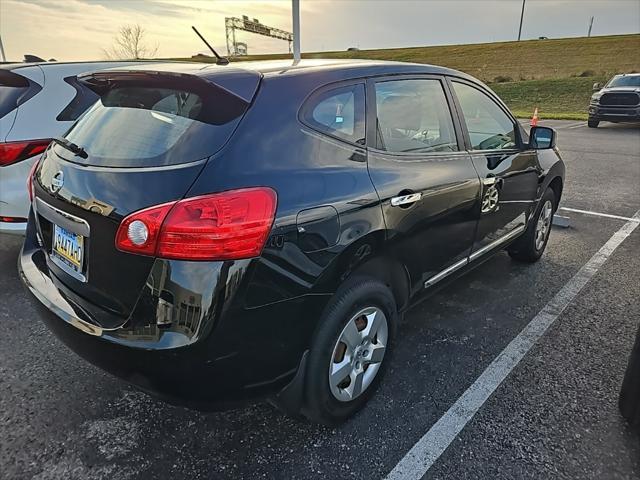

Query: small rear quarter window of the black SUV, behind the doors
[304,84,365,145]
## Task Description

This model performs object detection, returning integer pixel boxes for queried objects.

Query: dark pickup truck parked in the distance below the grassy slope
[588,73,640,128]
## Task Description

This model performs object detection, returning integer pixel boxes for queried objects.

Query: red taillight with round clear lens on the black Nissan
[116,187,277,260]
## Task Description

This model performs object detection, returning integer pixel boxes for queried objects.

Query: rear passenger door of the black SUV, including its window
[367,76,480,293]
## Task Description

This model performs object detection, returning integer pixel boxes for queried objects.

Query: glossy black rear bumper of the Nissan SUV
[18,218,326,409]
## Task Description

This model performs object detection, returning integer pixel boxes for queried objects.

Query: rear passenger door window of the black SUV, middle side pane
[376,79,458,153]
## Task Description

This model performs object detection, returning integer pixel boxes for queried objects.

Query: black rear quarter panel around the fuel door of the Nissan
[188,74,384,308]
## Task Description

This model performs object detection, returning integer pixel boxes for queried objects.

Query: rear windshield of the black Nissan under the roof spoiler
[54,85,247,167]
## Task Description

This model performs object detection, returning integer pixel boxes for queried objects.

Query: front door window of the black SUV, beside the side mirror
[453,82,517,150]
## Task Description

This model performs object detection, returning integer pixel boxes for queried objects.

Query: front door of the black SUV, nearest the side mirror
[451,80,542,260]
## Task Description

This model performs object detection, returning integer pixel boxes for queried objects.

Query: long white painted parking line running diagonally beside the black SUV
[386,210,640,480]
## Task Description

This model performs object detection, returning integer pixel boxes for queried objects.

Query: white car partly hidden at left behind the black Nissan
[0,61,158,234]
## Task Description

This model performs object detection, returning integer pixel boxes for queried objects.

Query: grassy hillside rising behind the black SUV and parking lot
[174,34,640,119]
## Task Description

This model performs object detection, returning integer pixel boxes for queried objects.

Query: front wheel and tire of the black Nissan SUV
[507,188,556,263]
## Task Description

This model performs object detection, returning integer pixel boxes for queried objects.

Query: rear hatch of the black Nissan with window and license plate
[33,67,260,318]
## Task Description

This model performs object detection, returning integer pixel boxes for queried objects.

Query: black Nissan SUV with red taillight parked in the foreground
[19,61,565,424]
